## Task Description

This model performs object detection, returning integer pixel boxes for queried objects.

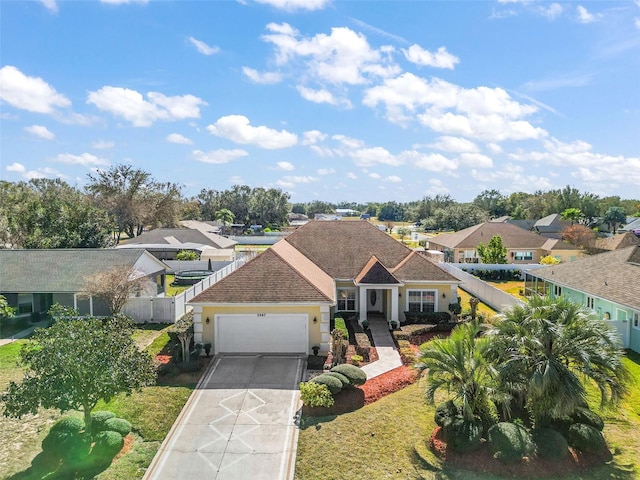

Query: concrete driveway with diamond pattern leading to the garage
[144,355,306,480]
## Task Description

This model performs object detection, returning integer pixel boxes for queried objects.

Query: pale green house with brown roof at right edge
[525,246,640,353]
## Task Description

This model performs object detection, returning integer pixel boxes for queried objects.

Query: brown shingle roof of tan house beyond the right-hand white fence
[429,222,547,249]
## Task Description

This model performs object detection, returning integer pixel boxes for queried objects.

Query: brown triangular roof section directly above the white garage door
[189,248,335,303]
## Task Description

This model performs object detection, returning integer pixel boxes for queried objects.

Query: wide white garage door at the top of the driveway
[215,314,309,353]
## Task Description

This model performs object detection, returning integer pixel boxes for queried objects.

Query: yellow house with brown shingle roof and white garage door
[189,221,460,354]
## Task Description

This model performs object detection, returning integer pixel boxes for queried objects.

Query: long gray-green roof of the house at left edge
[0,248,165,293]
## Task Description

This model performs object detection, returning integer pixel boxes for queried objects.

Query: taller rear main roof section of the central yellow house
[285,220,411,280]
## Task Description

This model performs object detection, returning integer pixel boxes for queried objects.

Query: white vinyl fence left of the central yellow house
[123,259,245,323]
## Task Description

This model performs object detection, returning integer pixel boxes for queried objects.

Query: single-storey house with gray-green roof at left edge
[0,248,166,318]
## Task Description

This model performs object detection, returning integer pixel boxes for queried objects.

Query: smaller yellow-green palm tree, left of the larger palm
[414,322,506,425]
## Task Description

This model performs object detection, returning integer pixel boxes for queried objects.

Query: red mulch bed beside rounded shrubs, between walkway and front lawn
[302,366,417,417]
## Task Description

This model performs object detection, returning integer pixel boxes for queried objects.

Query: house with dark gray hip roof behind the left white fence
[116,227,237,261]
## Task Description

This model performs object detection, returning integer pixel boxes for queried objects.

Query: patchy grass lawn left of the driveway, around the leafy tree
[0,324,200,480]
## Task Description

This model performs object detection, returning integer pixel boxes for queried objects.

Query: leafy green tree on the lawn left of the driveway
[1,310,155,431]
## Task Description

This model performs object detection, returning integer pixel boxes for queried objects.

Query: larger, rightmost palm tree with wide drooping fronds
[486,296,630,425]
